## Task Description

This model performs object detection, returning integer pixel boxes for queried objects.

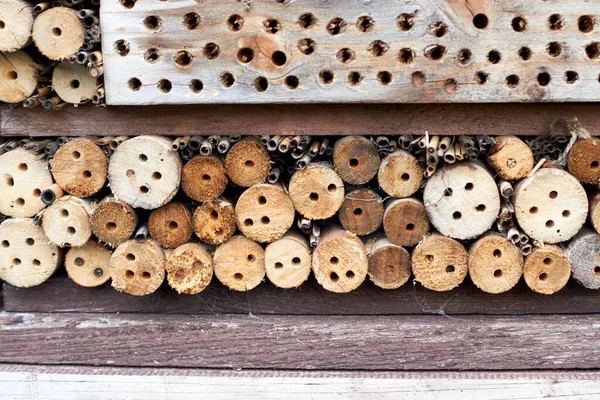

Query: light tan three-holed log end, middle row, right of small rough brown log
[235,183,295,243]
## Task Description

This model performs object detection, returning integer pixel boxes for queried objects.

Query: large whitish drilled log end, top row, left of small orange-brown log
[108,136,181,210]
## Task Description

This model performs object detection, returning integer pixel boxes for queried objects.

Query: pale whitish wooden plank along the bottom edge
[0,365,600,400]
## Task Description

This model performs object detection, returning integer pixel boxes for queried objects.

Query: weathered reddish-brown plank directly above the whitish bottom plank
[0,313,600,370]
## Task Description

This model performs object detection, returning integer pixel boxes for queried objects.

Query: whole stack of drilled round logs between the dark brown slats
[0,135,600,296]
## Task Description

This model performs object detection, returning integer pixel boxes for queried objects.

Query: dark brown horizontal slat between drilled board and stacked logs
[0,104,600,136]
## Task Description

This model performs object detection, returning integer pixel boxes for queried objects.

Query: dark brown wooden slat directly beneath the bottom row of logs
[4,278,600,315]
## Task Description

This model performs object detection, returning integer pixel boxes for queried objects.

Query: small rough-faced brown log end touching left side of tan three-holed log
[193,198,236,245]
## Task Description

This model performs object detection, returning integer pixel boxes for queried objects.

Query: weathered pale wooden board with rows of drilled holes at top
[101,0,600,105]
